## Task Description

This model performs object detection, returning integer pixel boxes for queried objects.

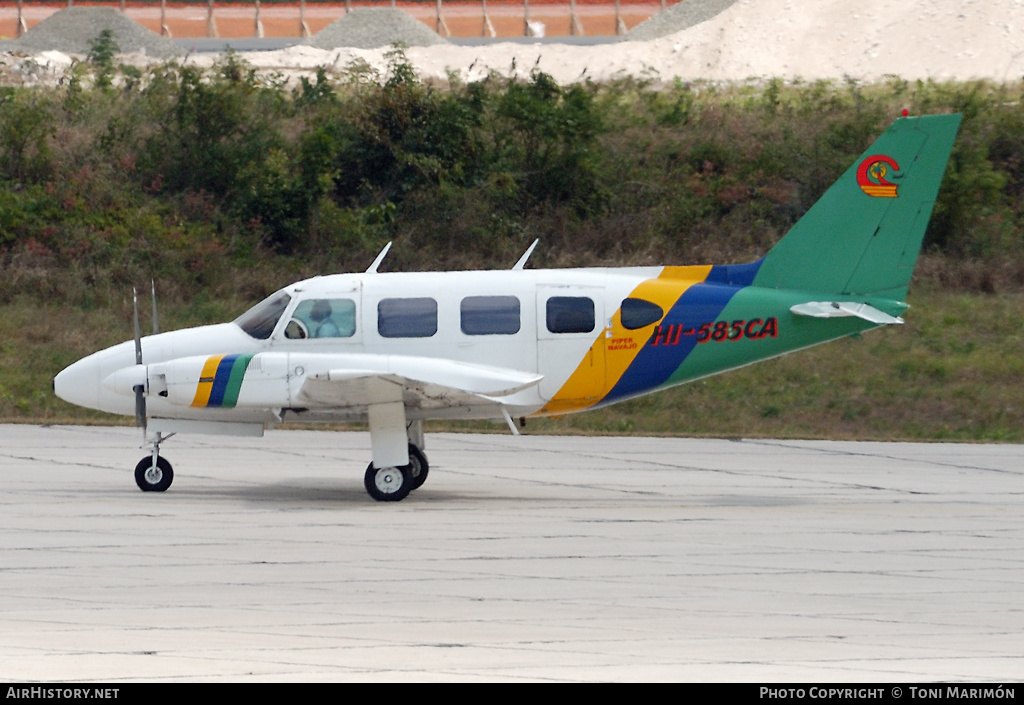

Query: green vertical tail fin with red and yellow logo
[754,115,961,300]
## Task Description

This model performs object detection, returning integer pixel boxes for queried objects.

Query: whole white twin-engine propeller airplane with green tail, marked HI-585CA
[53,115,959,501]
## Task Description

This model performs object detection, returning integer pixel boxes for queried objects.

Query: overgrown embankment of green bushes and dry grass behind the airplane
[0,48,1024,434]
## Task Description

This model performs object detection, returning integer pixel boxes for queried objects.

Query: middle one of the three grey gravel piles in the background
[307,7,449,49]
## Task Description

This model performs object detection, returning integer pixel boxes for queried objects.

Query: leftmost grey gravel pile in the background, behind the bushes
[10,7,185,58]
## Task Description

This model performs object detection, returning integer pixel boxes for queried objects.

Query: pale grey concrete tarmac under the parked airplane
[0,425,1024,683]
